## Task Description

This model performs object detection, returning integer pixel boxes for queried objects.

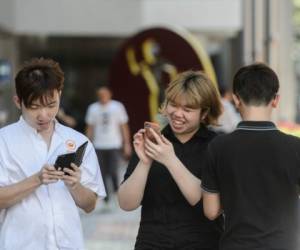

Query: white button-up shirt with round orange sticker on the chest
[0,117,106,250]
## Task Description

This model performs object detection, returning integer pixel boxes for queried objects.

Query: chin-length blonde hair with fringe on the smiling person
[160,70,222,125]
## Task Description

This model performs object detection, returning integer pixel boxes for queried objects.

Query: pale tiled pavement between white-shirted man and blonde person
[81,198,140,250]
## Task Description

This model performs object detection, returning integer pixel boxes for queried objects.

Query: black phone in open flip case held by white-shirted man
[54,141,88,170]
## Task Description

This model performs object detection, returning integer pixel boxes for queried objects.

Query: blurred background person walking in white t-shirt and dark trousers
[85,86,132,201]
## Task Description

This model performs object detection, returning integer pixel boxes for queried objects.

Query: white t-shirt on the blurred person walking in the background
[85,100,128,149]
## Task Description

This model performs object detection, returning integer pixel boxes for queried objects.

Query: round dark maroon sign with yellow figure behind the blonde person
[109,28,216,134]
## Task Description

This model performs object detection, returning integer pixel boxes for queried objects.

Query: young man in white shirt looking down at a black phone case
[0,58,105,250]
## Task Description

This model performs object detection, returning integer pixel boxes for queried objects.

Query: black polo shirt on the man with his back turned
[202,121,300,250]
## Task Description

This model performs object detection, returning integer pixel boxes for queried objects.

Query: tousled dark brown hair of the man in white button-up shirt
[15,58,64,107]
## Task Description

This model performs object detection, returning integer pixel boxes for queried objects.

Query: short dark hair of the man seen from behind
[233,63,279,106]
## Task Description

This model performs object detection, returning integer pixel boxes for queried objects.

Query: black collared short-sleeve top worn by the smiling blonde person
[124,126,221,249]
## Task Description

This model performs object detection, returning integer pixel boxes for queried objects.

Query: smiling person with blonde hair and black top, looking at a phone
[118,71,222,250]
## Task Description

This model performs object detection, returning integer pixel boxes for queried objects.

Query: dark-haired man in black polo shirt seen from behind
[202,64,300,250]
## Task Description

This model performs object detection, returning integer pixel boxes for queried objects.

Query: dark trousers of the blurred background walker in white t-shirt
[96,149,120,201]
